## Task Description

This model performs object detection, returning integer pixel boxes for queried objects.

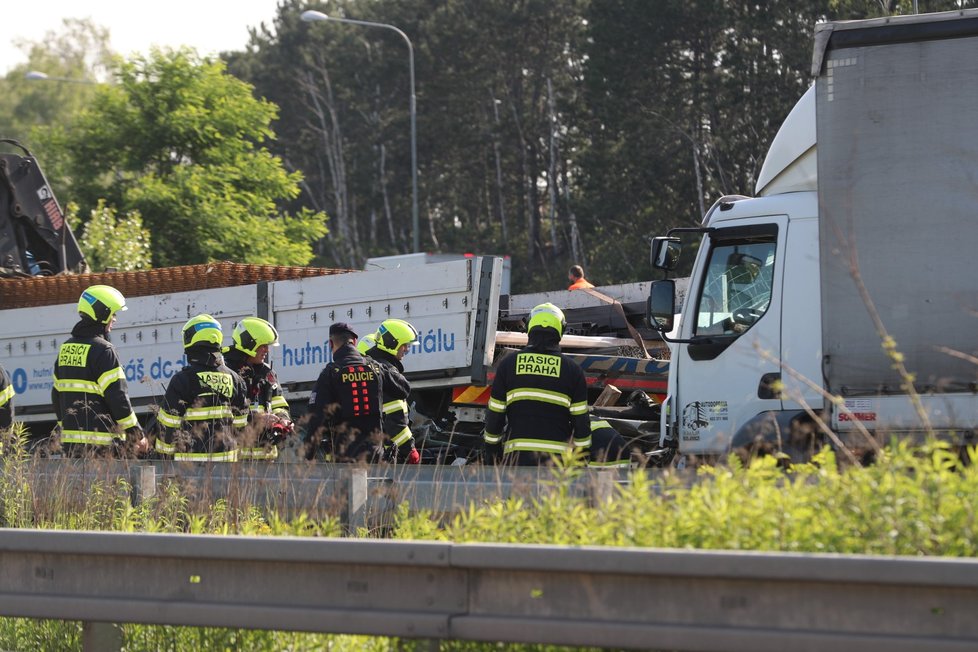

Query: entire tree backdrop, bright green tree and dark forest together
[7,0,978,282]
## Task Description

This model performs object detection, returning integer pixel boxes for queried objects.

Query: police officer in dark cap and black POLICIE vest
[304,322,387,463]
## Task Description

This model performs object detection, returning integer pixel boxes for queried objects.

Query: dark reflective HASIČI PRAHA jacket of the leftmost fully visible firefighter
[51,317,139,446]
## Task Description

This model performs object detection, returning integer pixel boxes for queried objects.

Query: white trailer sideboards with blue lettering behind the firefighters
[0,257,502,423]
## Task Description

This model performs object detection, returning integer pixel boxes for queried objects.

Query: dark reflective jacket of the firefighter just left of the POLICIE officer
[224,346,292,460]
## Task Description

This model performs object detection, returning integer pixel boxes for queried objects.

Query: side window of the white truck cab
[694,238,776,335]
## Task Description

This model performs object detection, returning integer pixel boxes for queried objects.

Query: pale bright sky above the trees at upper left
[0,0,278,76]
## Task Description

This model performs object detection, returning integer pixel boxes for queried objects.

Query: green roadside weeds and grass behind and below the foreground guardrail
[0,422,978,650]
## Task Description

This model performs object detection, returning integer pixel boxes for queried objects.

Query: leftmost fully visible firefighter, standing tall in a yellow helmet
[51,285,149,457]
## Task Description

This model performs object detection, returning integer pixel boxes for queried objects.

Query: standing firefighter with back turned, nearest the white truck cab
[483,303,591,466]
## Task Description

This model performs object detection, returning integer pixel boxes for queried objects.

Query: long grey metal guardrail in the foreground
[0,529,978,652]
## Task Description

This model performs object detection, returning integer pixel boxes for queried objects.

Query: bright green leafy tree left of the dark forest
[39,49,326,266]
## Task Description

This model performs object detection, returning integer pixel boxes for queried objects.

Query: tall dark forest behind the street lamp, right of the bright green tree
[228,0,975,291]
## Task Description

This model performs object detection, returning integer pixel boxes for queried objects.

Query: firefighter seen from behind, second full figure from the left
[156,314,248,462]
